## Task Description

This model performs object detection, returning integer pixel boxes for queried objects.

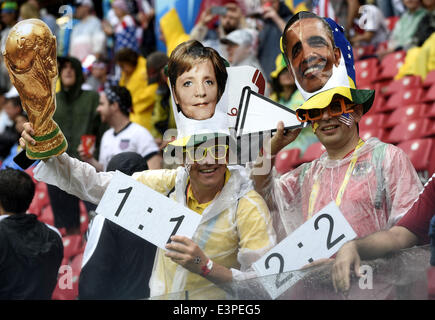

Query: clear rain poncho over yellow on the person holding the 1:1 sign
[34,153,276,299]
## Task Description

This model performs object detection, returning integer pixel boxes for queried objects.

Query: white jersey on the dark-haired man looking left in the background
[98,122,159,170]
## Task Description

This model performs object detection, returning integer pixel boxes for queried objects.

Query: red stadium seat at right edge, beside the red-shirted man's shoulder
[397,138,435,176]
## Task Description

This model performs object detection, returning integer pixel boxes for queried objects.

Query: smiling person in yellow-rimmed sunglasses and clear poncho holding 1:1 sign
[20,123,276,299]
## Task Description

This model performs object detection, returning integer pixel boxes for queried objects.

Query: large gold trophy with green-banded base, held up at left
[3,19,68,159]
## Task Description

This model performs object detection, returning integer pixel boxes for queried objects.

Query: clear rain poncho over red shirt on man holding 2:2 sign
[250,138,423,241]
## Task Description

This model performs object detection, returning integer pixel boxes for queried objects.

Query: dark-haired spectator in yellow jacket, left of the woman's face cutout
[115,48,158,131]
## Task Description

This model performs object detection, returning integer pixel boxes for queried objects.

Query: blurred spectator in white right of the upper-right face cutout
[350,4,389,47]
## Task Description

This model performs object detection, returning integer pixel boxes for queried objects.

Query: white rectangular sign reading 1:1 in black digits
[96,171,201,250]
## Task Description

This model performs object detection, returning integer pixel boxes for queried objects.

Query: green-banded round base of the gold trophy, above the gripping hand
[26,126,68,160]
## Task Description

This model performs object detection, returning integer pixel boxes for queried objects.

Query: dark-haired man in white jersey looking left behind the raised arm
[79,86,162,171]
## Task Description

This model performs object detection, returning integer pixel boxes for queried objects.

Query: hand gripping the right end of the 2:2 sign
[332,241,361,292]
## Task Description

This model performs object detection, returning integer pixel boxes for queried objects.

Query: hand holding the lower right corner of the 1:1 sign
[165,235,208,274]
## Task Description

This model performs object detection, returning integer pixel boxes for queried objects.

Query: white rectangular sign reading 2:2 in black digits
[253,202,356,298]
